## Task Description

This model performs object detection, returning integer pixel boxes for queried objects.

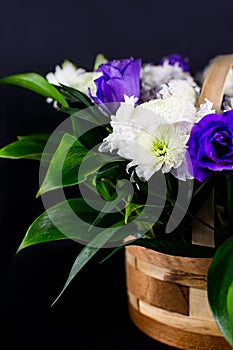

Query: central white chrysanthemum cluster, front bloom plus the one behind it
[99,80,214,181]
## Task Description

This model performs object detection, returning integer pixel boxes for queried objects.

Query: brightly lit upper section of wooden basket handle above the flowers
[198,54,233,113]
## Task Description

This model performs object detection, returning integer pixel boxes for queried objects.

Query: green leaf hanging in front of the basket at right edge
[207,237,233,346]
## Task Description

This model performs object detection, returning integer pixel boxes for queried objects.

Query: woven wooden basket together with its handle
[125,55,233,350]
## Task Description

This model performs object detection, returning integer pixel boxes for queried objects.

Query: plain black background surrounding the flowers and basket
[0,0,233,350]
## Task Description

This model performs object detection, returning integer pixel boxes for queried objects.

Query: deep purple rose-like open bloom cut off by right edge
[187,110,233,182]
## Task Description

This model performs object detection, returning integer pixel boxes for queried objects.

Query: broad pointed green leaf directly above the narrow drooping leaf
[18,198,124,252]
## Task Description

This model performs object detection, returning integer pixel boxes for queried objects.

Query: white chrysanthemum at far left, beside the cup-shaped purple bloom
[46,60,102,96]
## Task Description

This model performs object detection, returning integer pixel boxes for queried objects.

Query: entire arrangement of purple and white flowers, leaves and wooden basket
[0,54,233,349]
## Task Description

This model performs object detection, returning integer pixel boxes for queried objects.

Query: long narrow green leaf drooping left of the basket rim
[52,222,123,305]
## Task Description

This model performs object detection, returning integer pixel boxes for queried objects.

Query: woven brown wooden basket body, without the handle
[125,246,231,350]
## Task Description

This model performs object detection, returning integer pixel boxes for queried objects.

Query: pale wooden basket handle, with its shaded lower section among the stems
[192,54,233,247]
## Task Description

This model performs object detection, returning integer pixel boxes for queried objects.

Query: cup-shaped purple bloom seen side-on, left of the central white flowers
[90,57,141,112]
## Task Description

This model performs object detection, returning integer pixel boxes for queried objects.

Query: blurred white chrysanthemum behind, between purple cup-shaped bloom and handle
[140,61,197,90]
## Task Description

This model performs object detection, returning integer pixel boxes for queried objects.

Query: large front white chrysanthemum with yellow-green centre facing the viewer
[99,99,191,181]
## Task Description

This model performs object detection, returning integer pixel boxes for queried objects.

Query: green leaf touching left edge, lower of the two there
[0,134,49,160]
